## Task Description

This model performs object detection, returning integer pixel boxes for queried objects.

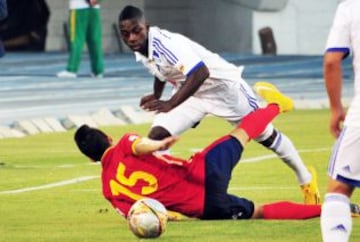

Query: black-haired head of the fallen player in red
[74,124,111,161]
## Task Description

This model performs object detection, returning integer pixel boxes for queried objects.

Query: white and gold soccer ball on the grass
[127,198,168,238]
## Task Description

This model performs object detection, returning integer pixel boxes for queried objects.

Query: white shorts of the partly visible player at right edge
[328,126,360,187]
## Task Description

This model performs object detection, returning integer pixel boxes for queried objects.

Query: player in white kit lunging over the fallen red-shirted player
[119,6,320,204]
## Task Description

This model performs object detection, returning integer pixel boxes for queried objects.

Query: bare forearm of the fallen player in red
[134,136,179,155]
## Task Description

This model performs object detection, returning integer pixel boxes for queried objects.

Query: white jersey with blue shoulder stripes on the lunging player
[135,26,247,95]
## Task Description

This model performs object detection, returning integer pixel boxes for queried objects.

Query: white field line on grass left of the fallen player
[0,176,99,195]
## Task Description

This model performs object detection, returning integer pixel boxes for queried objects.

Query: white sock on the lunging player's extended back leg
[269,131,312,185]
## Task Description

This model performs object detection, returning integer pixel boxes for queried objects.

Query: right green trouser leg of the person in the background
[86,8,104,77]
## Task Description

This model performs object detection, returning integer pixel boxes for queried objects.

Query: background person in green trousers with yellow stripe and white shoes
[57,0,104,78]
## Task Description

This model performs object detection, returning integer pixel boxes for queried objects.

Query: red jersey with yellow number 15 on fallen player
[102,133,205,217]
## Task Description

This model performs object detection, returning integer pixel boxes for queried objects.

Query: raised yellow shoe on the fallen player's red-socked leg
[253,82,294,112]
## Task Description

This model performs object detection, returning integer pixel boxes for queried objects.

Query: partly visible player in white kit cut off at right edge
[321,0,360,242]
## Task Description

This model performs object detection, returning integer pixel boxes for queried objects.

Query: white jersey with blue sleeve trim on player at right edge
[326,0,360,127]
